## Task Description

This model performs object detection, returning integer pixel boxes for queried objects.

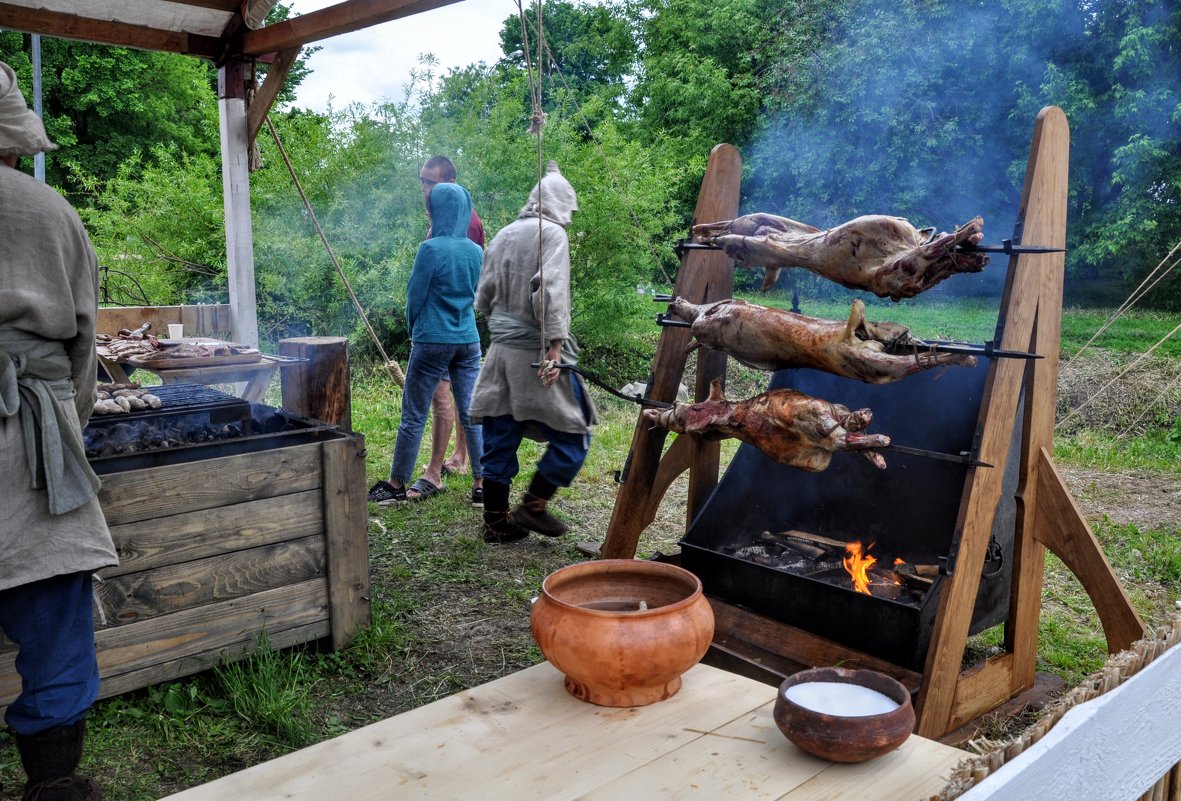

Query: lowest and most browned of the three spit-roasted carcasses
[644,379,889,473]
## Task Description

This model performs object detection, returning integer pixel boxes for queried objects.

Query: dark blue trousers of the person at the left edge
[0,573,98,735]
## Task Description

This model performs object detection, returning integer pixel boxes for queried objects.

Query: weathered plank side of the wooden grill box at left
[0,430,370,708]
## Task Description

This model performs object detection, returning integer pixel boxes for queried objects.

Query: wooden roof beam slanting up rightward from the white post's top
[242,0,458,56]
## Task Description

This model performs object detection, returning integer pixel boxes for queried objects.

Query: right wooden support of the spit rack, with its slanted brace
[916,106,1144,737]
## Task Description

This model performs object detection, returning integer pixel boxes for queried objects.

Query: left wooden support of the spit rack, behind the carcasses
[600,144,742,559]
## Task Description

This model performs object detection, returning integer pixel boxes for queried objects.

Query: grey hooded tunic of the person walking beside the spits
[470,162,599,437]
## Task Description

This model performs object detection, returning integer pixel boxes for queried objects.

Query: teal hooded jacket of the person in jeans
[406,183,484,345]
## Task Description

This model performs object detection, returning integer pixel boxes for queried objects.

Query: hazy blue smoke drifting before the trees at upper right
[743,0,1181,297]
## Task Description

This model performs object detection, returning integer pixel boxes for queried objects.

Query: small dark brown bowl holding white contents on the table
[775,668,914,762]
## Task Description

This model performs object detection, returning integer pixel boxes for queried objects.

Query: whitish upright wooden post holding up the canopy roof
[217,59,259,347]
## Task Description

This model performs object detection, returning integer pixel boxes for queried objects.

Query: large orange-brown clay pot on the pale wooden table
[531,559,713,706]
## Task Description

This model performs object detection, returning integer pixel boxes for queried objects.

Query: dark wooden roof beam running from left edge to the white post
[0,2,220,59]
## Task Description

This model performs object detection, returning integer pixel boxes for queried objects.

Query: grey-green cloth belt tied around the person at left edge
[0,328,102,515]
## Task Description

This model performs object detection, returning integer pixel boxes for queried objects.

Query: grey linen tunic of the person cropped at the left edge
[0,165,118,590]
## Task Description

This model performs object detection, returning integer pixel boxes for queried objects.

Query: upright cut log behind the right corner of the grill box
[279,337,353,431]
